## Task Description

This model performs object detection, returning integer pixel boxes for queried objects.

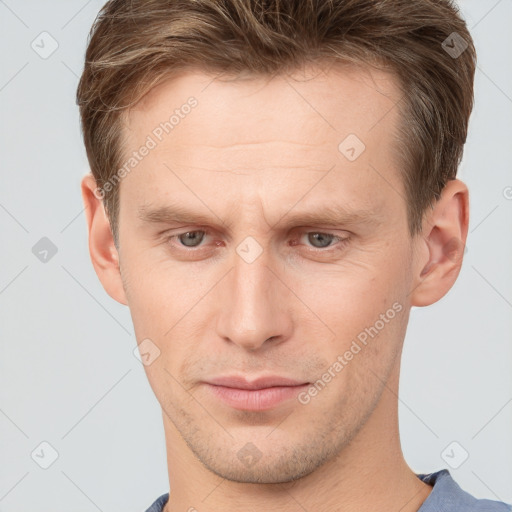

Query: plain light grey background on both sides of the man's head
[0,0,512,512]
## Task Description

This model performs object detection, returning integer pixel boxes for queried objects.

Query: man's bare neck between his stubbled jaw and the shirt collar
[164,360,432,512]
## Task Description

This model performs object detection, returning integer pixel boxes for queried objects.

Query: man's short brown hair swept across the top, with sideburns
[77,0,476,241]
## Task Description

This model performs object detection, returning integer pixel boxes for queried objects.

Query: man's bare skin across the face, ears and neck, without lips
[82,65,468,512]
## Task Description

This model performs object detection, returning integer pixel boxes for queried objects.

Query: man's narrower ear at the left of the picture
[82,174,128,305]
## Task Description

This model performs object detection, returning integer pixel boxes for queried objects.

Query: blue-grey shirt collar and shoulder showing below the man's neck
[146,469,512,512]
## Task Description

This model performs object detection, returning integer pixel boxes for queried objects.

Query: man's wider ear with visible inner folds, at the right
[410,179,469,306]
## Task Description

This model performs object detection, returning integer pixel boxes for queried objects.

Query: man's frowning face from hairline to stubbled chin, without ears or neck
[119,68,420,482]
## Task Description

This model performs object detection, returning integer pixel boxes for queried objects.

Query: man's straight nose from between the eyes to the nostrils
[217,244,293,351]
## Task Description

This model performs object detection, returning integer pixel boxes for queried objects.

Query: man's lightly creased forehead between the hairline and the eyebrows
[121,61,403,224]
